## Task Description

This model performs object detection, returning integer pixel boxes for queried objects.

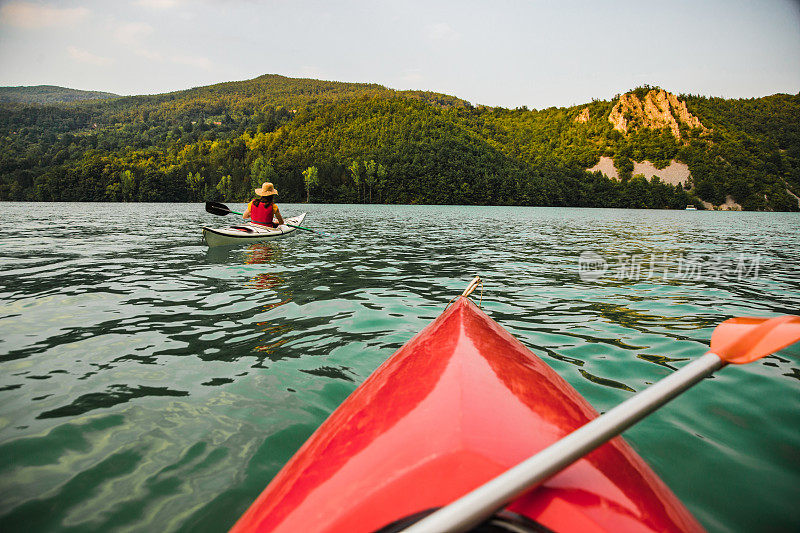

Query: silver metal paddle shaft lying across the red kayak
[404,352,727,533]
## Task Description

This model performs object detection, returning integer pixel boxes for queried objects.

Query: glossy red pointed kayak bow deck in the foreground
[232,298,702,533]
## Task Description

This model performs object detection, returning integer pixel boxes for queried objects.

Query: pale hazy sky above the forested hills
[0,0,800,109]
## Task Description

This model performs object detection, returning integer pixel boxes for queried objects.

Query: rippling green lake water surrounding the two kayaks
[0,203,800,532]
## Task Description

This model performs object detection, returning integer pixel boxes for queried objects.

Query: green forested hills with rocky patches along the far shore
[0,75,800,210]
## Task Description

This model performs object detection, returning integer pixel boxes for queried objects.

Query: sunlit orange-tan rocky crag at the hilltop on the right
[608,89,709,139]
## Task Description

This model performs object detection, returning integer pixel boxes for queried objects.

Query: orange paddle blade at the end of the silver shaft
[711,315,800,365]
